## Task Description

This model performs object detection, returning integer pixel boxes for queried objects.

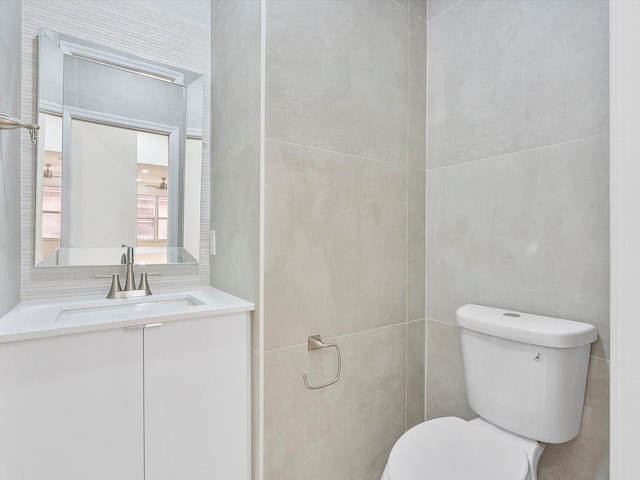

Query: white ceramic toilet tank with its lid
[456,305,597,443]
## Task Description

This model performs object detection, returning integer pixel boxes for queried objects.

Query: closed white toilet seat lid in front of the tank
[385,417,530,480]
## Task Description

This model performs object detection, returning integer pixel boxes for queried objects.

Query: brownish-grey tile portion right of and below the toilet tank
[538,357,609,480]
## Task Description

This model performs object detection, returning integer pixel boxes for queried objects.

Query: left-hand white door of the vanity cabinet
[0,329,144,480]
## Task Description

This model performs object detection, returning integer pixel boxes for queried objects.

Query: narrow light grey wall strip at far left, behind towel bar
[0,0,22,317]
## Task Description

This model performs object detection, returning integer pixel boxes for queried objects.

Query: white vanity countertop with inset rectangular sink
[0,287,255,343]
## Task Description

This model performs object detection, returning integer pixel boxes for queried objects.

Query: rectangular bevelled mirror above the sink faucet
[35,29,203,267]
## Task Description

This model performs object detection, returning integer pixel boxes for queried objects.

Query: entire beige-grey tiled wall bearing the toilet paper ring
[263,0,426,480]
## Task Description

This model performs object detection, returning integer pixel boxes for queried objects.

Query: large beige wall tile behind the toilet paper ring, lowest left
[264,324,406,480]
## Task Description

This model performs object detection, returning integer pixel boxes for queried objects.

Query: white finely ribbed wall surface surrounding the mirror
[20,0,211,299]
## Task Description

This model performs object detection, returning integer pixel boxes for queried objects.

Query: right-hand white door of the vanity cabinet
[144,313,250,480]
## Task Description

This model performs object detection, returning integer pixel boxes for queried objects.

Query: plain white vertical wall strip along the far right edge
[610,0,640,480]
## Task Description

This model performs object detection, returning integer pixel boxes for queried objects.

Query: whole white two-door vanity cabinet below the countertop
[0,289,253,480]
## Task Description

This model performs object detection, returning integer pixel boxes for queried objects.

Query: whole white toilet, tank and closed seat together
[381,305,597,480]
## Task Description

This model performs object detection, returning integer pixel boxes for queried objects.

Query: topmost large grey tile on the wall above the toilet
[427,0,609,168]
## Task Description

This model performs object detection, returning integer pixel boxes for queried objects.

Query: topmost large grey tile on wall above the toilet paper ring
[266,0,409,164]
